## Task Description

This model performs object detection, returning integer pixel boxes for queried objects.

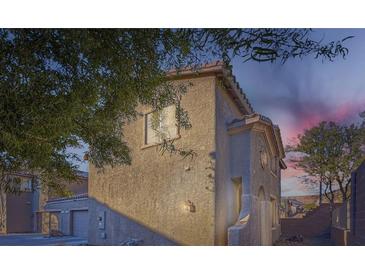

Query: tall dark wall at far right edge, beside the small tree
[349,159,365,245]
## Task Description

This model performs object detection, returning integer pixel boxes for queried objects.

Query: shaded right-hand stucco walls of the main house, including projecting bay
[215,87,280,245]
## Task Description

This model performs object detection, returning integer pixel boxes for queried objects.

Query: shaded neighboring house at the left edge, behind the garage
[0,172,87,233]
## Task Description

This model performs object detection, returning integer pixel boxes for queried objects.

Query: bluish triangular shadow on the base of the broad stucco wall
[88,198,179,246]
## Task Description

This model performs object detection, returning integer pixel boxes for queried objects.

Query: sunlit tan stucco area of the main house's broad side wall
[89,76,215,245]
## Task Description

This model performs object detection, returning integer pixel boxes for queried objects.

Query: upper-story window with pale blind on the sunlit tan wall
[145,105,179,145]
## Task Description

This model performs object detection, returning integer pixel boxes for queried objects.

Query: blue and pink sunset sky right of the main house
[233,29,365,196]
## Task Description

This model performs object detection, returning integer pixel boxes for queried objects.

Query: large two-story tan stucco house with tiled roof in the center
[88,62,286,245]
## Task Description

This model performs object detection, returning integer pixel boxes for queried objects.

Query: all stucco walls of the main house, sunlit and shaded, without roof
[89,73,280,245]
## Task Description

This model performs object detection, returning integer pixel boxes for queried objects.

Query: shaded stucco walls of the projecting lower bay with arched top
[226,125,280,245]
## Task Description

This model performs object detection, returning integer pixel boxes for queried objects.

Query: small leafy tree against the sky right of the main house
[289,114,365,207]
